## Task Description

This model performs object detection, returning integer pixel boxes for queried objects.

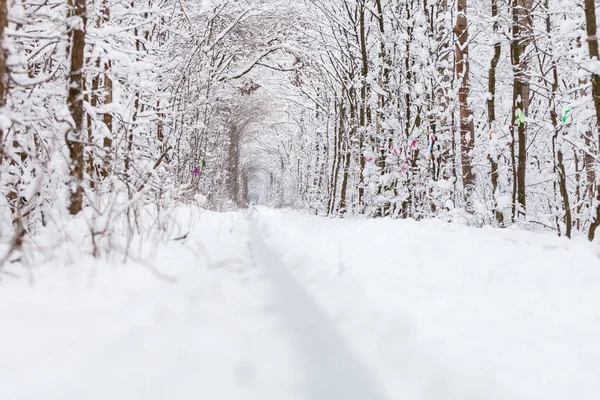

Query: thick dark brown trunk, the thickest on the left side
[66,0,87,215]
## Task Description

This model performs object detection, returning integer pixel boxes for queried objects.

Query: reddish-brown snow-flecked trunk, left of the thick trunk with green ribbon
[455,0,475,206]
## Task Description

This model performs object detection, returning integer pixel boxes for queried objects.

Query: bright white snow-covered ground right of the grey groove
[255,209,600,400]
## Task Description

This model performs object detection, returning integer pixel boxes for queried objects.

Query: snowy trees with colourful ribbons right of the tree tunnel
[276,0,600,239]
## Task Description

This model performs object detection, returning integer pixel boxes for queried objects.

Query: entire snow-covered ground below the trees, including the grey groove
[0,208,600,400]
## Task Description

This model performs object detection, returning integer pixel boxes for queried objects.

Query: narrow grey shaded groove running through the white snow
[249,209,388,400]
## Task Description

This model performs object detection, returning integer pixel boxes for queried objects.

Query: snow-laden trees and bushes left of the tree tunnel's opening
[0,0,298,256]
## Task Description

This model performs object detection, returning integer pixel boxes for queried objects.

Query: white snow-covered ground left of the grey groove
[0,212,302,400]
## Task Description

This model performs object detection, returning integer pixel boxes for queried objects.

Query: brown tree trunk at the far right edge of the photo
[584,0,600,241]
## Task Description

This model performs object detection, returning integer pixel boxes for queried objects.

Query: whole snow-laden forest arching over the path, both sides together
[0,0,600,265]
